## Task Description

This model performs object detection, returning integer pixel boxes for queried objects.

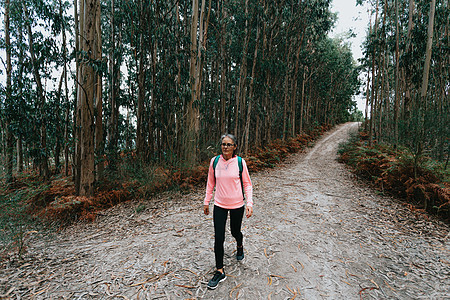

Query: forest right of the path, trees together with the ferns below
[341,0,450,222]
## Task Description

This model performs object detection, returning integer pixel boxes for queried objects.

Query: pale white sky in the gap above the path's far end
[330,0,369,112]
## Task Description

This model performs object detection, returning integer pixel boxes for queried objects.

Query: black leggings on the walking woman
[213,205,244,269]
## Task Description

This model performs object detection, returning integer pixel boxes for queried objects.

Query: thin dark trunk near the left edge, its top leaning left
[22,2,50,181]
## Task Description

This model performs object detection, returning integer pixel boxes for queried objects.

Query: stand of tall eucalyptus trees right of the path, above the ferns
[359,0,449,160]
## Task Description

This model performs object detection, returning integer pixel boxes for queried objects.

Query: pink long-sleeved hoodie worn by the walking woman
[204,155,253,209]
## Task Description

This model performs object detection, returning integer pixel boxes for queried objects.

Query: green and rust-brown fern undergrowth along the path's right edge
[339,133,450,222]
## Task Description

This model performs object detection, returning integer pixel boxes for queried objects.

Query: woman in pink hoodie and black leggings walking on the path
[203,134,253,289]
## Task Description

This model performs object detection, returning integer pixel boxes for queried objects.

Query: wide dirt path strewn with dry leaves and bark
[0,123,450,299]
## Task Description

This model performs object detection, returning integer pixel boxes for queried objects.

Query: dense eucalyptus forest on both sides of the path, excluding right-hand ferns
[0,0,450,225]
